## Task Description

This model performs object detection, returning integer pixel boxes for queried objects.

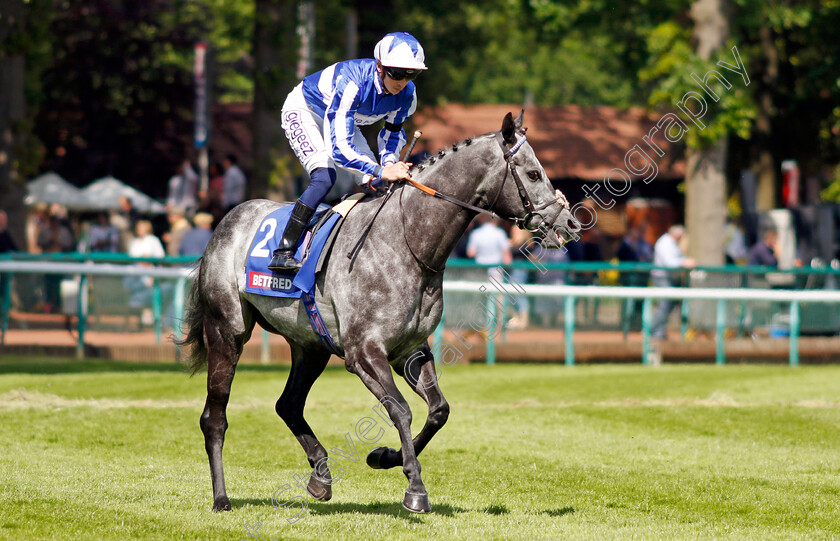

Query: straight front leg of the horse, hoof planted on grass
[346,343,432,513]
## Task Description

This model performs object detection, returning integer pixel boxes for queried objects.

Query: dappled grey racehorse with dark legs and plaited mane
[181,111,579,513]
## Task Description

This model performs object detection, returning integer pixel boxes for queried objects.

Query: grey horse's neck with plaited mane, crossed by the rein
[402,136,503,269]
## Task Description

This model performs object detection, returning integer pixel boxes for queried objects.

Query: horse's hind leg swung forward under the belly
[275,345,333,501]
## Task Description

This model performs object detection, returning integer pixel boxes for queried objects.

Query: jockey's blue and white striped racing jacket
[303,59,417,177]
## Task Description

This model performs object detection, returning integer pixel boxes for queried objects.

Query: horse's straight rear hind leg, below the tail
[200,318,253,511]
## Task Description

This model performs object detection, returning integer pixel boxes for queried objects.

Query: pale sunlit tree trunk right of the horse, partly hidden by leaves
[685,0,729,265]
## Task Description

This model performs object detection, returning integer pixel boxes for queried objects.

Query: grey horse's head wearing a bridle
[493,109,581,247]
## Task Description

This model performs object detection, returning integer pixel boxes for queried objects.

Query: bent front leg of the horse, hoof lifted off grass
[367,344,449,469]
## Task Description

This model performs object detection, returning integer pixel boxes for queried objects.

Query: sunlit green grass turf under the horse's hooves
[0,357,840,540]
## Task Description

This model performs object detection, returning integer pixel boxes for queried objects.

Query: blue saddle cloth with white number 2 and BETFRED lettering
[245,197,359,299]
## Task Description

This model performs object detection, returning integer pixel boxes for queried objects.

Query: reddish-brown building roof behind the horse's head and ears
[409,104,685,180]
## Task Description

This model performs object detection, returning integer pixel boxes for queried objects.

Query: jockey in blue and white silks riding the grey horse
[268,32,426,272]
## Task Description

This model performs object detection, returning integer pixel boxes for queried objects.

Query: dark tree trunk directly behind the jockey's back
[249,0,298,199]
